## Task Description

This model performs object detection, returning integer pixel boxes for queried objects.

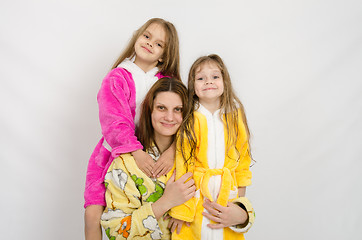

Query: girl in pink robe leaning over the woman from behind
[84,18,181,240]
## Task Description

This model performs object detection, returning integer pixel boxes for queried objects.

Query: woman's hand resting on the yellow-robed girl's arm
[161,172,196,209]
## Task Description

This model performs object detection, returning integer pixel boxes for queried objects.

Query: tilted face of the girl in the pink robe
[134,23,166,69]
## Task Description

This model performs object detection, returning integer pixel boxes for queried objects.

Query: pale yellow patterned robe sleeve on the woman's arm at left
[101,156,162,239]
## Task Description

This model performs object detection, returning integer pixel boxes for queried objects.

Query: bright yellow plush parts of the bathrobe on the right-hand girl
[169,111,255,240]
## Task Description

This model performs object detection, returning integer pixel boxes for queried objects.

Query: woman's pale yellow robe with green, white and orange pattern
[101,150,173,240]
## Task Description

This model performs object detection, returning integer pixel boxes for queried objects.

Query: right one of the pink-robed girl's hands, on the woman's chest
[152,143,176,178]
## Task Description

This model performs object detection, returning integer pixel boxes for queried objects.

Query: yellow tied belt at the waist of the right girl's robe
[194,167,232,206]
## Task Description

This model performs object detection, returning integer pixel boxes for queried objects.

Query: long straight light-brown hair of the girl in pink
[112,18,181,79]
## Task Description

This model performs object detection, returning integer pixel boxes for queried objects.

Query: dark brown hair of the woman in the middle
[136,77,189,155]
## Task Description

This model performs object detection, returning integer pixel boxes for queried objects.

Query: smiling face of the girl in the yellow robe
[194,62,224,105]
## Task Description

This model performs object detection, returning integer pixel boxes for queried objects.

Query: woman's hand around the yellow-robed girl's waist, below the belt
[202,199,248,229]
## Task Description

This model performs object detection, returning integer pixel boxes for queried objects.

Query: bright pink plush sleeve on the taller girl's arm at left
[97,68,142,158]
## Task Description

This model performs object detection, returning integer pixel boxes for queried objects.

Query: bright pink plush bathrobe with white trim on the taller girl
[84,67,164,207]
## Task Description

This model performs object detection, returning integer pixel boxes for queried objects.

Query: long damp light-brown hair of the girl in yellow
[180,54,251,165]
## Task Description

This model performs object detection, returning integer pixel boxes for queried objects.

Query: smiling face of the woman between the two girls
[151,92,182,141]
